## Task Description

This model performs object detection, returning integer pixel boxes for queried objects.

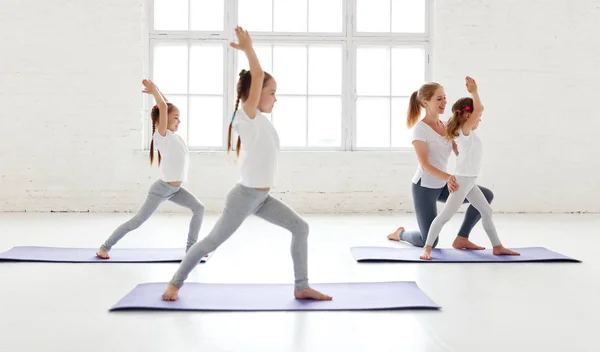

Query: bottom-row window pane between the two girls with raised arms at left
[189,96,223,147]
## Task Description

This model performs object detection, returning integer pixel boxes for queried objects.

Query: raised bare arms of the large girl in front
[230,27,265,119]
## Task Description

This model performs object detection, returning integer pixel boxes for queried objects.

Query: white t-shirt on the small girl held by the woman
[454,128,483,177]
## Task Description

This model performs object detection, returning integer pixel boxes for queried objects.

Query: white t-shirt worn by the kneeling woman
[412,121,452,188]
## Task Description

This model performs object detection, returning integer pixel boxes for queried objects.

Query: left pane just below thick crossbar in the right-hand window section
[356,47,390,96]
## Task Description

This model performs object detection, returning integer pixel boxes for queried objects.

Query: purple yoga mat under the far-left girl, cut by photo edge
[0,247,211,263]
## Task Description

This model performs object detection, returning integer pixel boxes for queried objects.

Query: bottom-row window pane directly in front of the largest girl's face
[271,97,306,147]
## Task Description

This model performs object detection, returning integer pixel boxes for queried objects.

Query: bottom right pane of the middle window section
[308,97,342,147]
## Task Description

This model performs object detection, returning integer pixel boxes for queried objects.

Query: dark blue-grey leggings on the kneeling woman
[400,180,494,247]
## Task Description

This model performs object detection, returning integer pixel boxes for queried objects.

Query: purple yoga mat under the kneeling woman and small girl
[350,247,581,263]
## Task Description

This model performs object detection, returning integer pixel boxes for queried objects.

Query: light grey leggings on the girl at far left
[102,180,204,251]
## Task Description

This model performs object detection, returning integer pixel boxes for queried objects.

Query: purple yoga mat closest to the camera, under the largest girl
[110,281,440,311]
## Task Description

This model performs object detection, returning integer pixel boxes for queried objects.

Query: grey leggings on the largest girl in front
[171,184,308,289]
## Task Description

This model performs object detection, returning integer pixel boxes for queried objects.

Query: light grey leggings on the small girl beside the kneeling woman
[425,176,501,247]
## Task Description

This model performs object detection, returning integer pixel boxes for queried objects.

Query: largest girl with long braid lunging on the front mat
[162,27,332,301]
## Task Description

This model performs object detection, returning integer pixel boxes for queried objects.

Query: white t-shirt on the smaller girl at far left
[154,130,190,182]
